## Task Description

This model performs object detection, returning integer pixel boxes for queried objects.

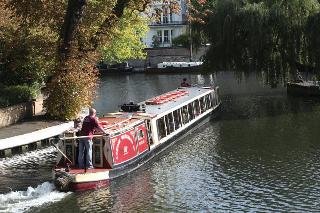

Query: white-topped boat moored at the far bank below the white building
[146,61,203,73]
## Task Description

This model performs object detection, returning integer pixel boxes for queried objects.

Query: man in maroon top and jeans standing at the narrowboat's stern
[78,108,107,169]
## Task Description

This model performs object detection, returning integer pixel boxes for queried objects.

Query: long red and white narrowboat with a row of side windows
[53,86,221,191]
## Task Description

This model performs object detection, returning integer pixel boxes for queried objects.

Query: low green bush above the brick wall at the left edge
[0,85,39,107]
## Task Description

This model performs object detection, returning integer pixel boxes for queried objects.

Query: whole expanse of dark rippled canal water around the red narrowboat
[0,72,320,213]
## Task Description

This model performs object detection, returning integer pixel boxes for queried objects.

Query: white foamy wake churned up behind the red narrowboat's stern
[0,182,70,212]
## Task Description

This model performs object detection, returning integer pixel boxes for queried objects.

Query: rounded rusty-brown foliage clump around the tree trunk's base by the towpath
[45,54,98,120]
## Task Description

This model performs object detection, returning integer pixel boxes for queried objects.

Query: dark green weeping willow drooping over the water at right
[192,0,320,82]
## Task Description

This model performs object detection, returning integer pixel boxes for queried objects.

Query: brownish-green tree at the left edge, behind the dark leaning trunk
[0,2,56,86]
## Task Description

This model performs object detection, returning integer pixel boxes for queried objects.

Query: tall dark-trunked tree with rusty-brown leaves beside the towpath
[1,0,177,119]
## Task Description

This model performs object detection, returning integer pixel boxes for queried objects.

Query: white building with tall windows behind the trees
[142,0,188,48]
